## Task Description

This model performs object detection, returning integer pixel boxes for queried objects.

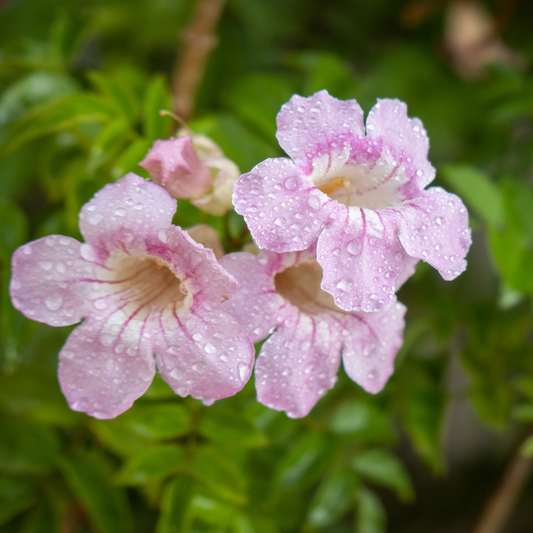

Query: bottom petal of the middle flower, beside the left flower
[255,308,340,418]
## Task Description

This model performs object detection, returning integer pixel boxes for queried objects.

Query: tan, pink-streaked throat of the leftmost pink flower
[93,255,192,320]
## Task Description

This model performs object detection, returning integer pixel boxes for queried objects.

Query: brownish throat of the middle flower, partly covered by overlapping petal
[274,261,343,315]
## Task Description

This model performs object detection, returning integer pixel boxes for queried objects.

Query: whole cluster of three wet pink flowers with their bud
[11,91,471,418]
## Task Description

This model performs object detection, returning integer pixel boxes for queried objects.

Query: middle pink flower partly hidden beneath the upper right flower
[220,246,405,418]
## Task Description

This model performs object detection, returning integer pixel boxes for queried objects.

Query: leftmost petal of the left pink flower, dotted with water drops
[10,235,94,326]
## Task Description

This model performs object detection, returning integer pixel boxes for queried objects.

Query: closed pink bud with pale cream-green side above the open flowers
[139,130,240,216]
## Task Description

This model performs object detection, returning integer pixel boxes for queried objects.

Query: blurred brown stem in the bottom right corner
[473,434,533,533]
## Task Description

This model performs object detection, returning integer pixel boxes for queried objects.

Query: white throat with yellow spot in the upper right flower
[310,148,409,209]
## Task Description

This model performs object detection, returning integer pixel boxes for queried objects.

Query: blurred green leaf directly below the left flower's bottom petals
[115,402,192,439]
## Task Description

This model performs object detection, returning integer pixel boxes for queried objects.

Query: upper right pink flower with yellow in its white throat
[233,91,471,311]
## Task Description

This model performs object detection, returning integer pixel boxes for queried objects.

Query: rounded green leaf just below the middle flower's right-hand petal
[330,400,394,442]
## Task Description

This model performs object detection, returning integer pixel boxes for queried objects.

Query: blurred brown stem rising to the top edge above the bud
[172,0,224,121]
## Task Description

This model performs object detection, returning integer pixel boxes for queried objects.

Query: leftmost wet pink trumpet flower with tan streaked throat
[10,174,254,418]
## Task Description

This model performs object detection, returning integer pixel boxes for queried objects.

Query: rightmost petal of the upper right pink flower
[397,187,472,280]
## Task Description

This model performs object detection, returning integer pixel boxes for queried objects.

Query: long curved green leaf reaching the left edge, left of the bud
[3,93,114,152]
